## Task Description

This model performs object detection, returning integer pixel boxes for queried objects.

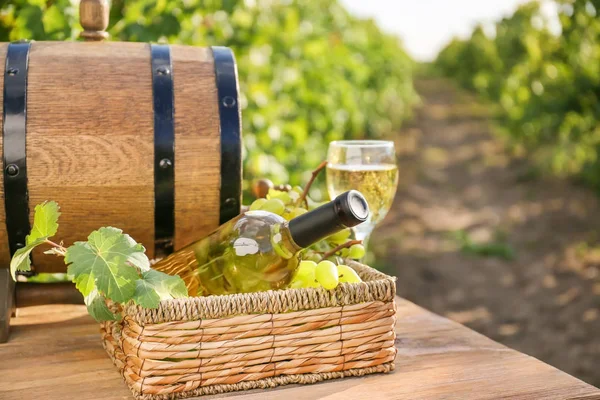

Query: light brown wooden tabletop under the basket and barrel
[0,299,600,400]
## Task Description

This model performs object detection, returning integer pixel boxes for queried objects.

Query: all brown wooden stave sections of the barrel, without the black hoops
[0,42,230,272]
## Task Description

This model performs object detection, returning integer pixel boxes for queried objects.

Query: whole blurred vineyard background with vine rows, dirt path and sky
[0,0,600,386]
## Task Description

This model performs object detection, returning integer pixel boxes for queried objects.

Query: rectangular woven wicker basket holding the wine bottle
[102,262,396,400]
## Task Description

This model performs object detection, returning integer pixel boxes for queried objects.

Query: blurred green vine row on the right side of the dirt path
[436,0,600,189]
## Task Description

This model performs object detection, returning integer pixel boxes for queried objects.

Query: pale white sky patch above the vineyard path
[341,0,526,61]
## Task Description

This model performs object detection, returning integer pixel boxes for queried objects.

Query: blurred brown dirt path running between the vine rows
[371,80,600,386]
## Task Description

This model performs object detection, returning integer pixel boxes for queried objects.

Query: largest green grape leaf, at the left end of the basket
[65,227,144,303]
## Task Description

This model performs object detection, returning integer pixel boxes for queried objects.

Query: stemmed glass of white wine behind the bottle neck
[327,140,398,247]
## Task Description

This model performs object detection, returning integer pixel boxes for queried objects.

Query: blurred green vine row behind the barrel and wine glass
[0,0,416,198]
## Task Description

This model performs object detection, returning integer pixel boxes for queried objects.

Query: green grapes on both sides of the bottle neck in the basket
[250,185,365,290]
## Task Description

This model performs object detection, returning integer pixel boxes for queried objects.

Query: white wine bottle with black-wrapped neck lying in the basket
[153,190,369,296]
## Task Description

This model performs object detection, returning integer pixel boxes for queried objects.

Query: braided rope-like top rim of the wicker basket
[122,260,396,326]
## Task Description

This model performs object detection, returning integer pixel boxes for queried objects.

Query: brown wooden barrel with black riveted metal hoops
[0,42,241,272]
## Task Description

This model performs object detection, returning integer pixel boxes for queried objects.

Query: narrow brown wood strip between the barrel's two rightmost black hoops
[171,45,221,252]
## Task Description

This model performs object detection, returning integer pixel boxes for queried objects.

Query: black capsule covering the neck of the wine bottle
[289,190,369,247]
